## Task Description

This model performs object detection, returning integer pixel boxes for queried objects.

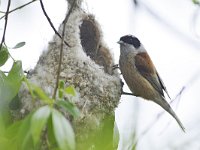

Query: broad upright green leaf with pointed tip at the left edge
[0,61,24,111]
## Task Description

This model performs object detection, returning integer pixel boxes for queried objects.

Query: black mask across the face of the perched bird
[120,35,141,48]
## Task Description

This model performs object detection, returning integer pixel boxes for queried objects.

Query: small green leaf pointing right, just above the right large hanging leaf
[56,100,80,117]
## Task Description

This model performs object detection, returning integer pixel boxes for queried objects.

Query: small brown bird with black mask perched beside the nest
[117,35,185,132]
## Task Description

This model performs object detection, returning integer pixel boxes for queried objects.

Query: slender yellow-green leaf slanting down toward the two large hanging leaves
[30,84,54,105]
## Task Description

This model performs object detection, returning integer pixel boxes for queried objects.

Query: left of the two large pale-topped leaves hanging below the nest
[31,106,51,145]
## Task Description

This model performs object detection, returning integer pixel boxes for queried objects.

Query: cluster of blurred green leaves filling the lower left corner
[0,42,79,150]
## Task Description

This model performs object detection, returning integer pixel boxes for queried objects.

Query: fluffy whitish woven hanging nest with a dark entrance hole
[15,3,121,127]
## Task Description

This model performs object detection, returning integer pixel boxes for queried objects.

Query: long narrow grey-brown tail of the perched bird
[155,98,185,132]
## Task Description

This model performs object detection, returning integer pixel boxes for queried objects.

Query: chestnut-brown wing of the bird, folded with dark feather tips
[135,53,168,97]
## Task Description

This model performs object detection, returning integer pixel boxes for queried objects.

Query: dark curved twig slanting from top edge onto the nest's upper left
[40,0,70,47]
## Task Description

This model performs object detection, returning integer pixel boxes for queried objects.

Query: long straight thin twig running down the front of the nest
[52,0,76,99]
